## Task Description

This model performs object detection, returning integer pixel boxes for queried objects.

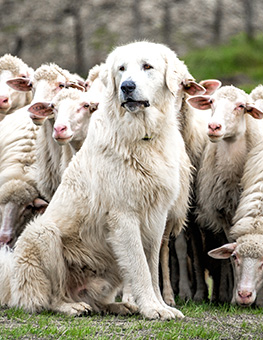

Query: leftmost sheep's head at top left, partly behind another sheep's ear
[0,54,34,120]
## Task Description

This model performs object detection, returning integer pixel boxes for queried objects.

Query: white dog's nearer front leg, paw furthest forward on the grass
[106,212,183,320]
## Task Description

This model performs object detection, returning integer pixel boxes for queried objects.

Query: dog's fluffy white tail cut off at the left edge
[0,246,13,306]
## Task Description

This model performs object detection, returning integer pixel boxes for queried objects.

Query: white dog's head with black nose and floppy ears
[100,42,187,113]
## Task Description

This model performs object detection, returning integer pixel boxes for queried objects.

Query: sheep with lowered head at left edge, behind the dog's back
[0,108,47,247]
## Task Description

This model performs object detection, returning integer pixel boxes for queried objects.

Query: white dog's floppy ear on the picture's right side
[165,50,192,94]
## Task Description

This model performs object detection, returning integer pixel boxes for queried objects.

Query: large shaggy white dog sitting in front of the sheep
[0,42,190,320]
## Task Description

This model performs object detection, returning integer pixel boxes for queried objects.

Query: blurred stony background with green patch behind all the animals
[0,0,263,91]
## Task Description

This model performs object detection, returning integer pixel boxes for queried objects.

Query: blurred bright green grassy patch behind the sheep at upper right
[182,33,263,93]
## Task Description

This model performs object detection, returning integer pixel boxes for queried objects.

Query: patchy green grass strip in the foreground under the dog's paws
[0,301,263,340]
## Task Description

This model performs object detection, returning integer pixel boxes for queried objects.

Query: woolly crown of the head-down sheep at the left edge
[0,179,38,204]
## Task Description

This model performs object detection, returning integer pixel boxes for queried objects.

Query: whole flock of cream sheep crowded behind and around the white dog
[0,41,263,318]
